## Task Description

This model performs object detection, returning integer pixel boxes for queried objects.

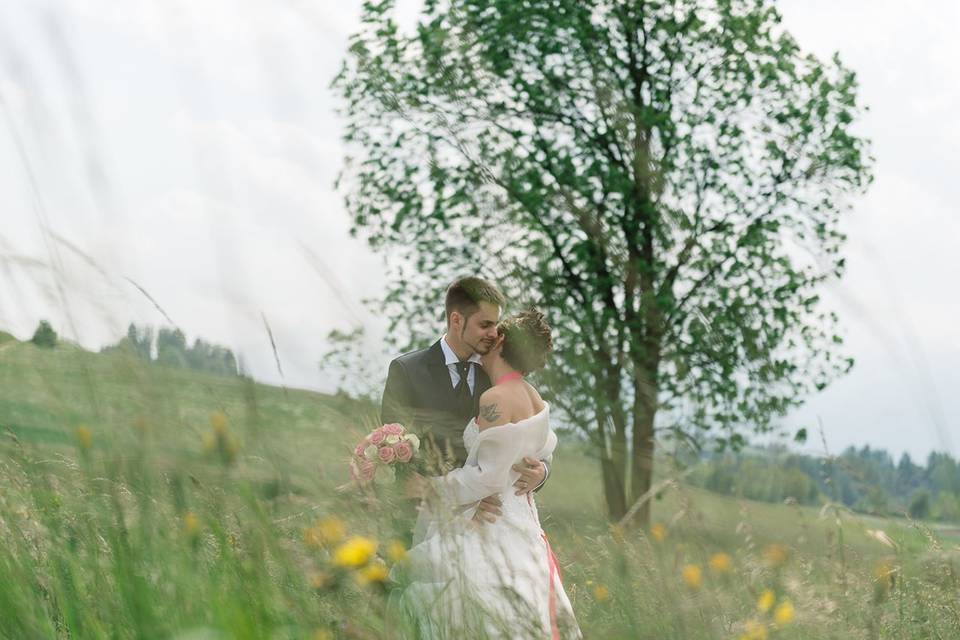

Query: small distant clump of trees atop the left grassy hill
[101,323,239,376]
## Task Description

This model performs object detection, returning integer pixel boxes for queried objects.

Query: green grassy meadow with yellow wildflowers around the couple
[0,334,960,640]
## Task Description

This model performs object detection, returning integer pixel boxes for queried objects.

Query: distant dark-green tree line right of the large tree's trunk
[691,446,960,522]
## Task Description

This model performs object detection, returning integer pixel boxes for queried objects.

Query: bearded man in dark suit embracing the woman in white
[380,277,549,522]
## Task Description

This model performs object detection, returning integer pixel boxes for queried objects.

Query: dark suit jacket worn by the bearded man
[380,340,490,466]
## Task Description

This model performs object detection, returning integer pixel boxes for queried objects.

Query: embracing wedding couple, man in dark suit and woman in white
[381,278,580,639]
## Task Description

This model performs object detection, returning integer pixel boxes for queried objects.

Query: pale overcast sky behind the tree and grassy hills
[0,0,960,458]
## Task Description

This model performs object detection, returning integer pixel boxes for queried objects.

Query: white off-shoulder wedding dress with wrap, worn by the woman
[402,405,580,640]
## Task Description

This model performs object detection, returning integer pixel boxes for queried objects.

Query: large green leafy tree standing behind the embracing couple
[335,0,870,524]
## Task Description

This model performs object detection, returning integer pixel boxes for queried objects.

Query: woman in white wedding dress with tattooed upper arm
[401,310,580,639]
